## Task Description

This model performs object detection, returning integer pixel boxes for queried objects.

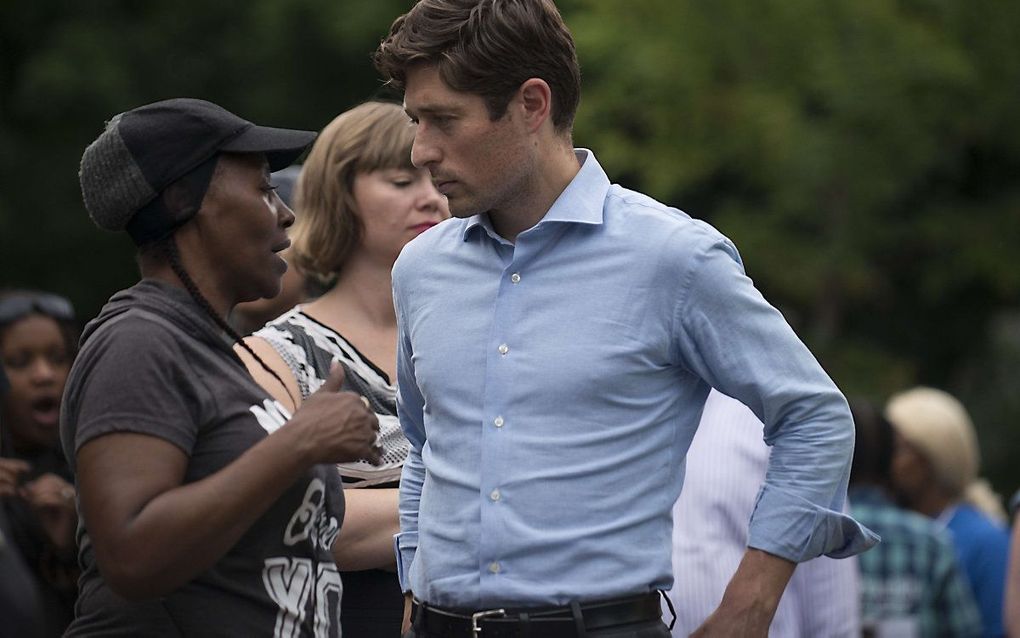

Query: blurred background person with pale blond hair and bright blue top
[885,387,1009,636]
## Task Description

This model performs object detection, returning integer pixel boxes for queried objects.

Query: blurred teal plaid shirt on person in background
[850,486,981,638]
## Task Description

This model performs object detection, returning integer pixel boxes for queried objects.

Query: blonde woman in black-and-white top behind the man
[239,102,449,637]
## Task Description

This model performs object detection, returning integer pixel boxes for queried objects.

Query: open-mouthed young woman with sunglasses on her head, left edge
[0,291,78,636]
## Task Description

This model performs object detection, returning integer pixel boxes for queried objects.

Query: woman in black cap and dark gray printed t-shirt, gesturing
[61,99,379,636]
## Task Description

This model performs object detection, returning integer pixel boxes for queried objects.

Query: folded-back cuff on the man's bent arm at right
[748,483,880,562]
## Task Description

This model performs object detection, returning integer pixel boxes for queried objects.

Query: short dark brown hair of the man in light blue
[374,0,580,132]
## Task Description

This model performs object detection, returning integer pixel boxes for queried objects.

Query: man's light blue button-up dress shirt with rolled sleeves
[393,150,875,608]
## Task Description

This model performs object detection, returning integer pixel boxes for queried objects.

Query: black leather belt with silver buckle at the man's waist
[411,592,662,638]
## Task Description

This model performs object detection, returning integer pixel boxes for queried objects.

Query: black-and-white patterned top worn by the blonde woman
[254,305,410,487]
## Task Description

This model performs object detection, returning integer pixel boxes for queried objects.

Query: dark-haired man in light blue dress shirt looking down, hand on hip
[375,0,875,638]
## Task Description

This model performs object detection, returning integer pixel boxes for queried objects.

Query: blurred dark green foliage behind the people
[0,0,1020,491]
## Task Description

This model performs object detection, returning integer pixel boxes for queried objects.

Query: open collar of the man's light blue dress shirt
[463,148,610,241]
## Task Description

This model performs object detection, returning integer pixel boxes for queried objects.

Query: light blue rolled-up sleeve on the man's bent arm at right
[674,234,878,562]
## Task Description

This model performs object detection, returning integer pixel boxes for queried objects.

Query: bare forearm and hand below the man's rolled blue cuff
[692,548,797,638]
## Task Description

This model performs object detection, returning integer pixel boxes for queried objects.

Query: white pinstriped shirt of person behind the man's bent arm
[666,390,873,638]
